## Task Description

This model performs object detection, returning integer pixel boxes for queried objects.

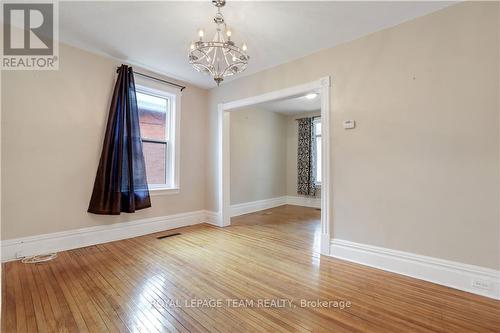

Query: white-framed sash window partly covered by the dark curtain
[136,80,180,193]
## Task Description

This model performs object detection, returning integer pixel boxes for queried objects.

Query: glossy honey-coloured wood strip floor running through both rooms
[1,206,500,333]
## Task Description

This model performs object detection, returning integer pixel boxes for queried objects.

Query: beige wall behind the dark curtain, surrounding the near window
[1,45,208,239]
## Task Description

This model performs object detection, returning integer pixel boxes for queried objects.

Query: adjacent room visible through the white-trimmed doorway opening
[229,92,322,252]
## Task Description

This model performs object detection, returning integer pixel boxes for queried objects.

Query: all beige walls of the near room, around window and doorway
[1,2,500,269]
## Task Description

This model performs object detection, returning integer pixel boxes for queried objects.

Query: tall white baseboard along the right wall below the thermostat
[330,239,500,300]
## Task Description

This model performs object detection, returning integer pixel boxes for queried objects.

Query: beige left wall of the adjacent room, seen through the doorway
[229,108,287,205]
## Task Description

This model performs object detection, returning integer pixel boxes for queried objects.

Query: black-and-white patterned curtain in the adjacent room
[297,118,317,196]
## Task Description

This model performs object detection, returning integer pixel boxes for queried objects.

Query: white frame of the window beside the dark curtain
[134,77,182,196]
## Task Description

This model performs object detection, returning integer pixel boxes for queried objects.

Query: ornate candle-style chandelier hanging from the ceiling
[189,0,250,85]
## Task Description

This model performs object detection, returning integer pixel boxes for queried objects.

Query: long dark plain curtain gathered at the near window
[88,65,151,215]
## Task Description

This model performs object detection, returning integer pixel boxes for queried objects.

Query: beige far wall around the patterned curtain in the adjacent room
[286,111,321,198]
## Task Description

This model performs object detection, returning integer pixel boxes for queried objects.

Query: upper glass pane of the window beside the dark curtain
[137,92,168,141]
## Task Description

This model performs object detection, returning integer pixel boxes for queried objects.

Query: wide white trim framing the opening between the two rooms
[218,76,332,255]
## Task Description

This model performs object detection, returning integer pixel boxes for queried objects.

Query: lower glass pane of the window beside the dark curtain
[142,142,167,185]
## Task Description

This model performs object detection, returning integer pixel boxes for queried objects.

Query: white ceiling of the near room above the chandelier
[59,0,451,88]
